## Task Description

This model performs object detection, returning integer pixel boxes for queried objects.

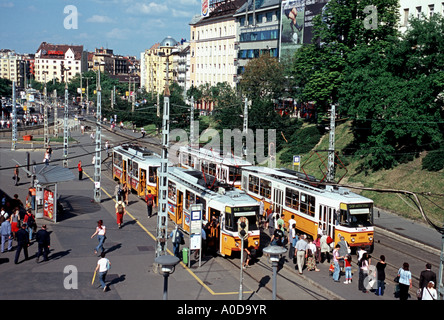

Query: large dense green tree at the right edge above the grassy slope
[340,17,444,169]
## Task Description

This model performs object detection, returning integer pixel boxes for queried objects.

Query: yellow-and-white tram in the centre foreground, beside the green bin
[168,167,260,256]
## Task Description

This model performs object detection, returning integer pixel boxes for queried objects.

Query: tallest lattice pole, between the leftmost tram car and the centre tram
[156,56,170,257]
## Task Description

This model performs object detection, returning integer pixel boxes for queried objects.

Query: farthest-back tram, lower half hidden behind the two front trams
[178,146,252,189]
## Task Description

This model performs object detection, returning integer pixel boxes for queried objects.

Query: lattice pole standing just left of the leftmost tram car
[94,68,102,203]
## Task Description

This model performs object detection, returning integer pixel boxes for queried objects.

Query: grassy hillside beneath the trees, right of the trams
[277,122,444,225]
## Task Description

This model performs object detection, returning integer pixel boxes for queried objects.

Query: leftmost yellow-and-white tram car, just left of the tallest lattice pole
[113,144,166,197]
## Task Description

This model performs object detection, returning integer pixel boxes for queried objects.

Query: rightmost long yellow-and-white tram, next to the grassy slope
[242,167,374,251]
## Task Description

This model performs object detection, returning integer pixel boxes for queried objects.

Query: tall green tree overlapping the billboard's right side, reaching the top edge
[291,0,398,119]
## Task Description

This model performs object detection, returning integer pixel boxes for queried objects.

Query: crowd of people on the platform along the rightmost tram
[264,205,437,300]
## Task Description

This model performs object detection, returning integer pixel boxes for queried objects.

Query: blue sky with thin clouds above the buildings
[0,0,201,58]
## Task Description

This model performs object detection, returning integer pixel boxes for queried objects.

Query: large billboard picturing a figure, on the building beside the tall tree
[279,0,328,57]
